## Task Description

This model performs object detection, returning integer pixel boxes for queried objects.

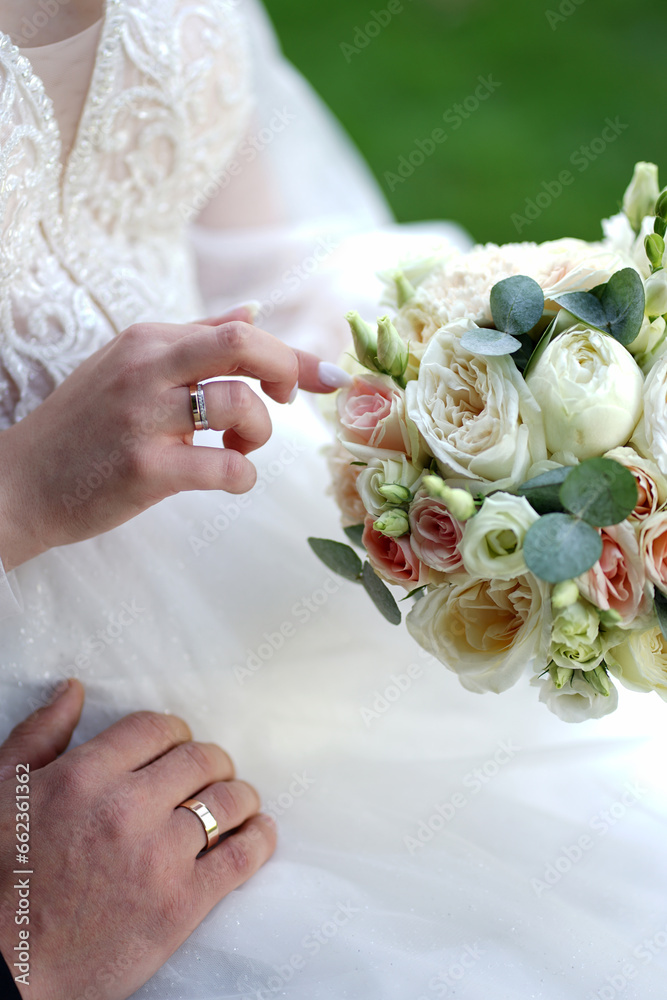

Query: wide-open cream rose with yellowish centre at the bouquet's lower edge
[407,575,551,694]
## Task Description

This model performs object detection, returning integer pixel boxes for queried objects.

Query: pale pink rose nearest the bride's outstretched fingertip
[337,375,419,458]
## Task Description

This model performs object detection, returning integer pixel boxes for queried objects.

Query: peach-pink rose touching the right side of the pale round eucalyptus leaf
[577,521,650,626]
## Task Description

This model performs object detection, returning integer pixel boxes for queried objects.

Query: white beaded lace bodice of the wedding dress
[0,0,251,427]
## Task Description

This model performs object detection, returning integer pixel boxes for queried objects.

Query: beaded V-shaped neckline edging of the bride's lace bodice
[0,0,122,191]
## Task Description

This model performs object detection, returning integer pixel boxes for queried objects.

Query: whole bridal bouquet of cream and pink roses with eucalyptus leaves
[310,163,667,721]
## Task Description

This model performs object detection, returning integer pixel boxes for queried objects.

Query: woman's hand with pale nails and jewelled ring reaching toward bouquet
[0,308,342,570]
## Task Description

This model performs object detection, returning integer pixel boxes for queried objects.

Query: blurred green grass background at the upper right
[266,0,667,242]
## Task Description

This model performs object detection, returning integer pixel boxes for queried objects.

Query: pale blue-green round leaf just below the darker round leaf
[523,514,602,583]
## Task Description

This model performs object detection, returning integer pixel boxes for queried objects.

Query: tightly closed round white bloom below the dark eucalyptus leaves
[527,325,644,461]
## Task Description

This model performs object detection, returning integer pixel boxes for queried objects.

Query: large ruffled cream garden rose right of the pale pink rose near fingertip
[406,321,546,488]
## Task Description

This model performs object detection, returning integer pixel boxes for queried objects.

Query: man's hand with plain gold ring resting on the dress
[0,681,276,1000]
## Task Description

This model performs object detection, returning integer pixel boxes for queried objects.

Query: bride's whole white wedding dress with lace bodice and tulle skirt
[0,0,667,1000]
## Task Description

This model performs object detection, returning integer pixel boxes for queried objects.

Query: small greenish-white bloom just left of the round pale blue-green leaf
[461,493,539,580]
